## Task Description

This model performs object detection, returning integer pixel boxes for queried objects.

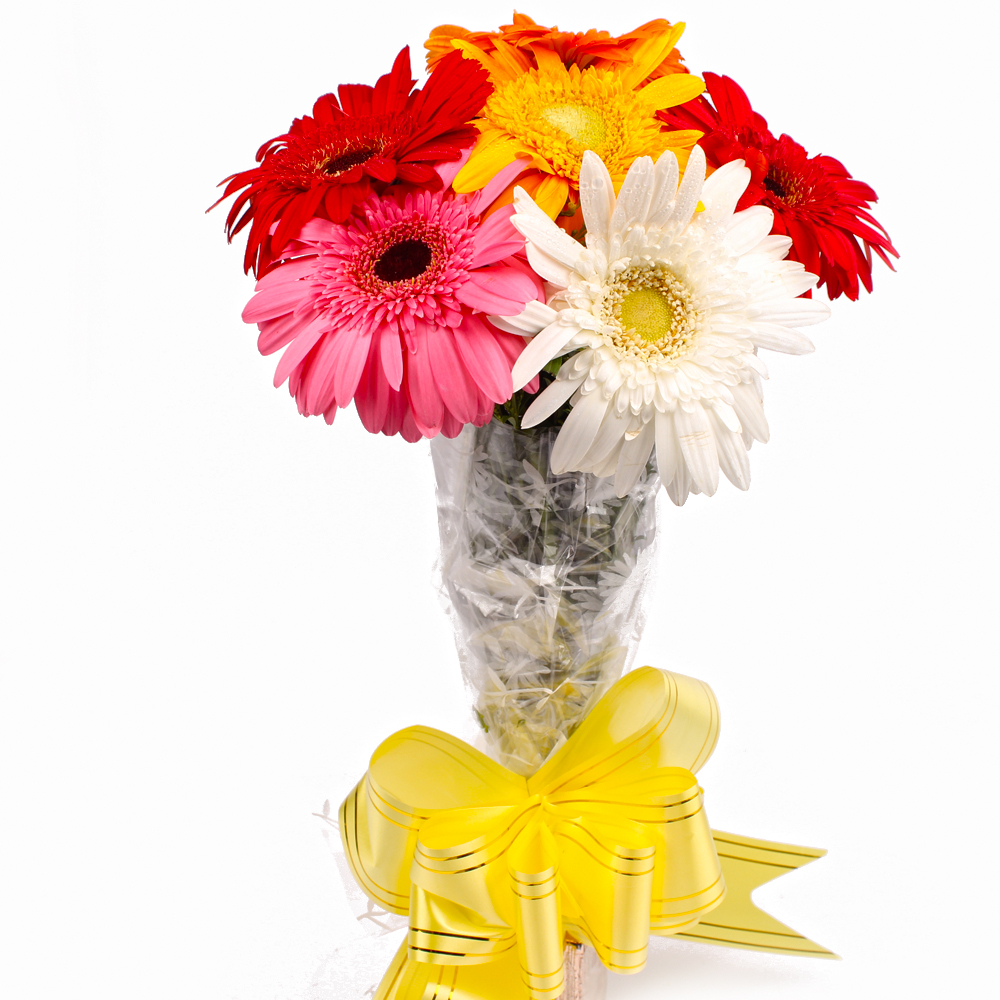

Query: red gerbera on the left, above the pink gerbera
[212,47,493,275]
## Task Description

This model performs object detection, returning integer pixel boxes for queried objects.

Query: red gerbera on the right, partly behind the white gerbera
[657,73,899,299]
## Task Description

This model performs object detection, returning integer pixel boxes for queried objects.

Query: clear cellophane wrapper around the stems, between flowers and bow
[431,421,659,775]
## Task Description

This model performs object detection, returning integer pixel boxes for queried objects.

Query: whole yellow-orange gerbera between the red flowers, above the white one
[453,33,704,218]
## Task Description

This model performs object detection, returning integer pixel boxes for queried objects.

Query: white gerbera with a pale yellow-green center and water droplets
[494,146,829,504]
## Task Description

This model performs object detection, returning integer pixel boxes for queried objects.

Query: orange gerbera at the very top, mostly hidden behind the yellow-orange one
[424,11,688,78]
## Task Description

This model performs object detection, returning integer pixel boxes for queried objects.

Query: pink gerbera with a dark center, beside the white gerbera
[243,164,542,441]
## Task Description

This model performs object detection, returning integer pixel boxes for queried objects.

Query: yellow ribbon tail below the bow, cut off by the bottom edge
[374,941,530,1000]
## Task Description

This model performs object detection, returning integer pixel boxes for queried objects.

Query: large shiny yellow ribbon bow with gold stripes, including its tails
[340,667,835,1000]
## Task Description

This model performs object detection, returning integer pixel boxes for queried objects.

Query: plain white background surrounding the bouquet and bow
[0,0,998,1000]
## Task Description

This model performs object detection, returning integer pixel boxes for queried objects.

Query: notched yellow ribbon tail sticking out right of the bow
[674,830,840,958]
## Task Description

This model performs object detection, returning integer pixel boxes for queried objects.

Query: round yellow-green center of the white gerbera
[602,264,698,362]
